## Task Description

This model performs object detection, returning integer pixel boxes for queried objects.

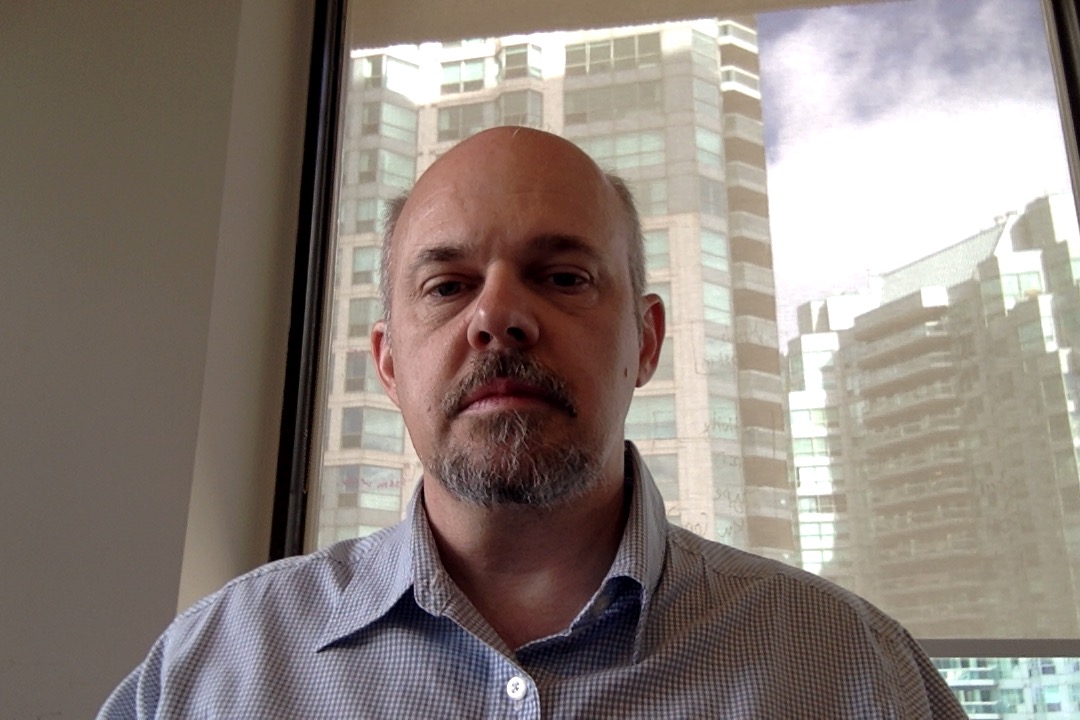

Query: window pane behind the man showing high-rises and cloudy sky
[309,0,1080,664]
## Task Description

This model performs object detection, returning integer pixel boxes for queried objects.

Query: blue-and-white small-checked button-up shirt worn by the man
[98,444,967,720]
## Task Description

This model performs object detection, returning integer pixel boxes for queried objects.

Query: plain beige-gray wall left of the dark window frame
[0,0,311,718]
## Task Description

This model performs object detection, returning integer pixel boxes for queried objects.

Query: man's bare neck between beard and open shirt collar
[423,476,626,650]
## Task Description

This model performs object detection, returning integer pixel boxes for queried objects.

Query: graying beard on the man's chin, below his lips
[432,411,602,508]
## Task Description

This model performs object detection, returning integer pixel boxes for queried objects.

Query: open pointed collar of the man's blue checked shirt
[316,441,667,650]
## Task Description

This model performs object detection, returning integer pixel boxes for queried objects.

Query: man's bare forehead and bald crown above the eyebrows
[393,136,624,260]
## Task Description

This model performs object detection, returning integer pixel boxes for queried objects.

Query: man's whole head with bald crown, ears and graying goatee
[372,128,663,505]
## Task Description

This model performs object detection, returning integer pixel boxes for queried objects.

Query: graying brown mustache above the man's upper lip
[441,350,578,419]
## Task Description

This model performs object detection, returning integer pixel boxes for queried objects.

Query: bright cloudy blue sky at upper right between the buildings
[758,0,1068,338]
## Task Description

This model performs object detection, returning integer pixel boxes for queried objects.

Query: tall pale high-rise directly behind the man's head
[318,17,797,561]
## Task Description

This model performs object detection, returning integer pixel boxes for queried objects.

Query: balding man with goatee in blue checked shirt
[100,127,964,719]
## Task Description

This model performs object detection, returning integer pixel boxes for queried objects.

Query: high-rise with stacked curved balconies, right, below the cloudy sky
[788,195,1080,638]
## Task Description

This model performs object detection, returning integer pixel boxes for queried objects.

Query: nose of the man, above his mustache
[469,266,540,350]
